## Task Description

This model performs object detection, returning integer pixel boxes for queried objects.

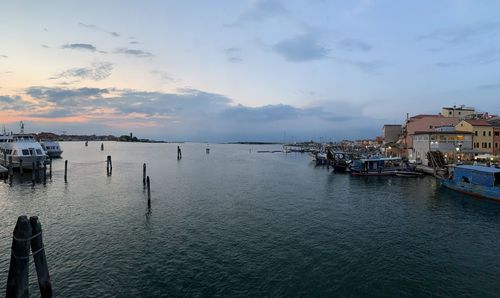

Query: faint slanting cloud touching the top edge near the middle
[225,0,287,27]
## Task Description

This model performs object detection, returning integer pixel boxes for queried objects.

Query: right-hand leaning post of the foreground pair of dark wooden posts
[30,216,52,298]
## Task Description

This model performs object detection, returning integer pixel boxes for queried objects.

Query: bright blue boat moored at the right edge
[440,165,500,201]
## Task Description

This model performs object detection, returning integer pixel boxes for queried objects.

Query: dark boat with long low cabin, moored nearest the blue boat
[351,157,410,176]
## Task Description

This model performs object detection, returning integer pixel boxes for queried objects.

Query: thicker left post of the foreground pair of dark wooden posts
[5,215,31,297]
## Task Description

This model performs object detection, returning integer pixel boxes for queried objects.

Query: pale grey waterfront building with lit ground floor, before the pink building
[413,127,473,165]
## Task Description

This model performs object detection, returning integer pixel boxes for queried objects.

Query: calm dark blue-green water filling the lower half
[0,142,500,297]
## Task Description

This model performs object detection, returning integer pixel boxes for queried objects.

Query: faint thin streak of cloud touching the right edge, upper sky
[418,22,500,44]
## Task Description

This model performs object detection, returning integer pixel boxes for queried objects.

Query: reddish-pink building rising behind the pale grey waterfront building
[403,115,460,159]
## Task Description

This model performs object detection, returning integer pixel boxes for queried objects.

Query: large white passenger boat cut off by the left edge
[0,122,47,169]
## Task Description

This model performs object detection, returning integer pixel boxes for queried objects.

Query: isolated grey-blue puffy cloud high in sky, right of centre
[273,34,330,62]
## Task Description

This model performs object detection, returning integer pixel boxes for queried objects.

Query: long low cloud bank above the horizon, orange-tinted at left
[0,86,382,141]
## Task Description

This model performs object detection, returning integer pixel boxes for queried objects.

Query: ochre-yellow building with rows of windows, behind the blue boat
[455,119,494,155]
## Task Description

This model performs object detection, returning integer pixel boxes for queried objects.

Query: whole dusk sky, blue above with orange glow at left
[0,0,500,142]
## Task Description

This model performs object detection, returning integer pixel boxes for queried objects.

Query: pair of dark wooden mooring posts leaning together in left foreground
[5,215,52,298]
